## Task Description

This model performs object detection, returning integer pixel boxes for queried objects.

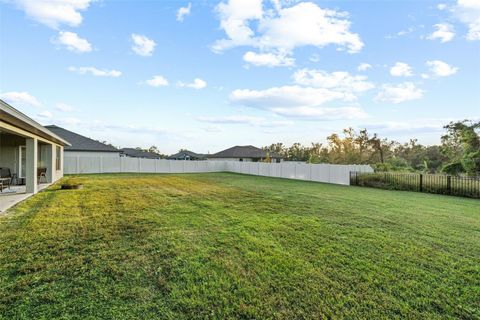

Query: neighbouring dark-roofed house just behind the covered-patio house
[45,125,121,158]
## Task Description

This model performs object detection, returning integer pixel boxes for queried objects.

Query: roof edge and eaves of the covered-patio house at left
[0,100,70,146]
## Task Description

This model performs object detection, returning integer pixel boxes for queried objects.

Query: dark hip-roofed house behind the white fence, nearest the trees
[208,146,282,162]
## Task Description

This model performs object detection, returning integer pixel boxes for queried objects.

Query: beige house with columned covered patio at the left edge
[0,100,70,195]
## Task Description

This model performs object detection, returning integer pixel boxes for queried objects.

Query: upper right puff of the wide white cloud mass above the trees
[293,69,374,94]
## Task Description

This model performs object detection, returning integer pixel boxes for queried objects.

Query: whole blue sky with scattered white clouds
[0,0,480,153]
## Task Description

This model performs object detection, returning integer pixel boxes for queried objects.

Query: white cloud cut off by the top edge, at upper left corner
[14,0,92,29]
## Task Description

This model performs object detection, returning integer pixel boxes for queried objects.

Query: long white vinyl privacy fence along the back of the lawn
[64,156,373,185]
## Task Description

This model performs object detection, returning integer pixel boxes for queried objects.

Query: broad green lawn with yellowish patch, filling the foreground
[0,173,480,319]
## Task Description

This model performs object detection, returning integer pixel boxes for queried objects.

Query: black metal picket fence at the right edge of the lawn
[350,172,480,198]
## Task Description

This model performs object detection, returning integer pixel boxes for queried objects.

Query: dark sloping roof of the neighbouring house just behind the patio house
[45,125,120,152]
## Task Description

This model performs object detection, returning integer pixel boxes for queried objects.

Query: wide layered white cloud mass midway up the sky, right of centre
[229,68,374,120]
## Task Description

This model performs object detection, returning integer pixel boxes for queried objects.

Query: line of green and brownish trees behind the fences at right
[263,120,480,176]
